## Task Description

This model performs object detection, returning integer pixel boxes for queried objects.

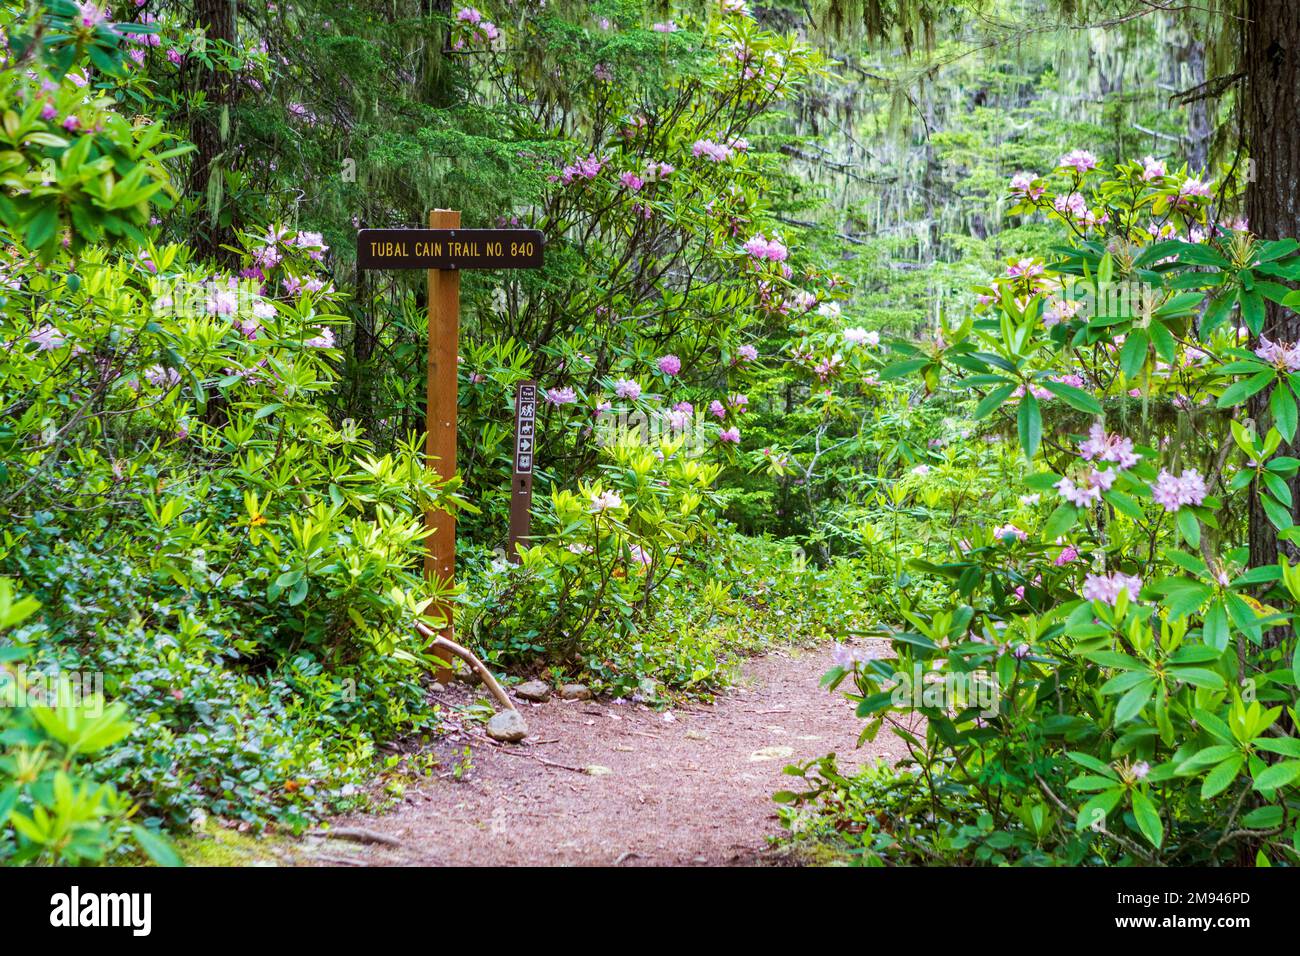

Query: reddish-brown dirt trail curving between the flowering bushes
[299,646,902,866]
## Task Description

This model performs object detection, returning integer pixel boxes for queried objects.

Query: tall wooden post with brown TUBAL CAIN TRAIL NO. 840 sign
[356,209,542,679]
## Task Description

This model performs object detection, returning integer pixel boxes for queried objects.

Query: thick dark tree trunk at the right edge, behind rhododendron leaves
[1242,0,1300,582]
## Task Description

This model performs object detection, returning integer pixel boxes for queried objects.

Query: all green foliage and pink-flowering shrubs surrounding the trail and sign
[0,0,1300,865]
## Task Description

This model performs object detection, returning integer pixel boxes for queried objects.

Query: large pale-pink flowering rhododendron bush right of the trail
[783,150,1300,864]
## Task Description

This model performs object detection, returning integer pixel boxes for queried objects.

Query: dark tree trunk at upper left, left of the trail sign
[189,0,237,258]
